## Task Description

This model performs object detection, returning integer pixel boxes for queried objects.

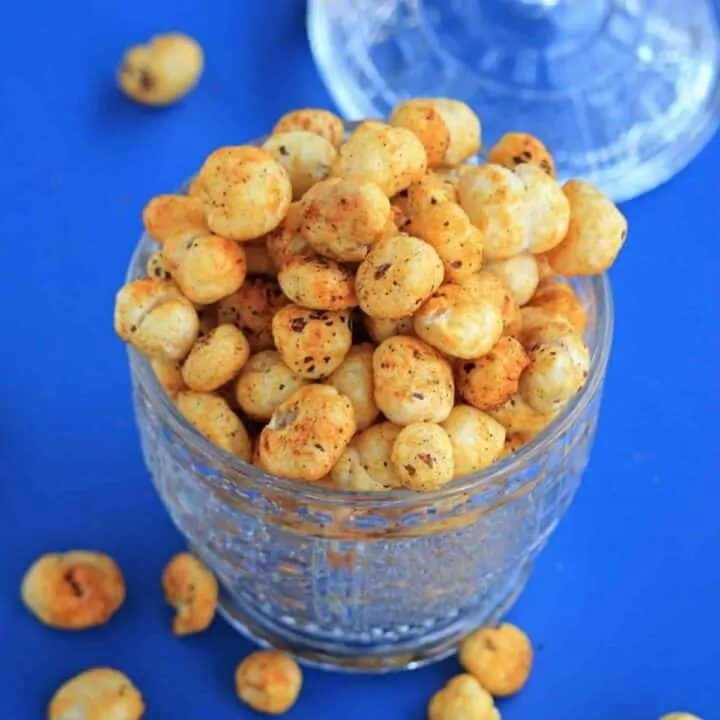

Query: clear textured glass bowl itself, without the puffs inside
[127,131,613,672]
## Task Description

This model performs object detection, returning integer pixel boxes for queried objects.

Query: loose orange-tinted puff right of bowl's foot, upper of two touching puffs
[459,623,533,697]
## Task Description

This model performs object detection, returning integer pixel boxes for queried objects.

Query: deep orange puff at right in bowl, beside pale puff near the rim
[455,337,530,411]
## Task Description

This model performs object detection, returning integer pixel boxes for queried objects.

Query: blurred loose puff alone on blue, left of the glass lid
[117,33,204,106]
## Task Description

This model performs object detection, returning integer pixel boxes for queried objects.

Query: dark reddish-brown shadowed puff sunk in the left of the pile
[216,277,288,352]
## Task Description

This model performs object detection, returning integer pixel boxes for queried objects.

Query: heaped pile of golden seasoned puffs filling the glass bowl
[115,98,627,492]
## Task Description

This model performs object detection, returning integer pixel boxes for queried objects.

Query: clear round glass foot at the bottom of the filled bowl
[218,567,530,674]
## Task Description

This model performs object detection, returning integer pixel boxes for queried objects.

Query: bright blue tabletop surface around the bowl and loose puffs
[0,0,720,720]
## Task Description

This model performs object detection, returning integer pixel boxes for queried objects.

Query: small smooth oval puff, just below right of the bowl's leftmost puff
[182,324,250,392]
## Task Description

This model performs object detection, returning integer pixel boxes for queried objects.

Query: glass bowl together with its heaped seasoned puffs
[117,100,624,669]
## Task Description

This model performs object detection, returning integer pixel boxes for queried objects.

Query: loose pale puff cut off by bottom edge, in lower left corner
[47,668,145,720]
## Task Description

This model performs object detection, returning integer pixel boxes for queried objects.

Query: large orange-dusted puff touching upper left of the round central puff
[295,178,396,262]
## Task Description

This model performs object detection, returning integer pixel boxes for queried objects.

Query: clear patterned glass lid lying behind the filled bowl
[308,0,720,201]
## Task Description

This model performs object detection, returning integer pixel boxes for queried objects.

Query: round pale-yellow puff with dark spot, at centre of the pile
[355,235,445,318]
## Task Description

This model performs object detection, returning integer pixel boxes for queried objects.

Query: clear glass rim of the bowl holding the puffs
[125,129,614,511]
